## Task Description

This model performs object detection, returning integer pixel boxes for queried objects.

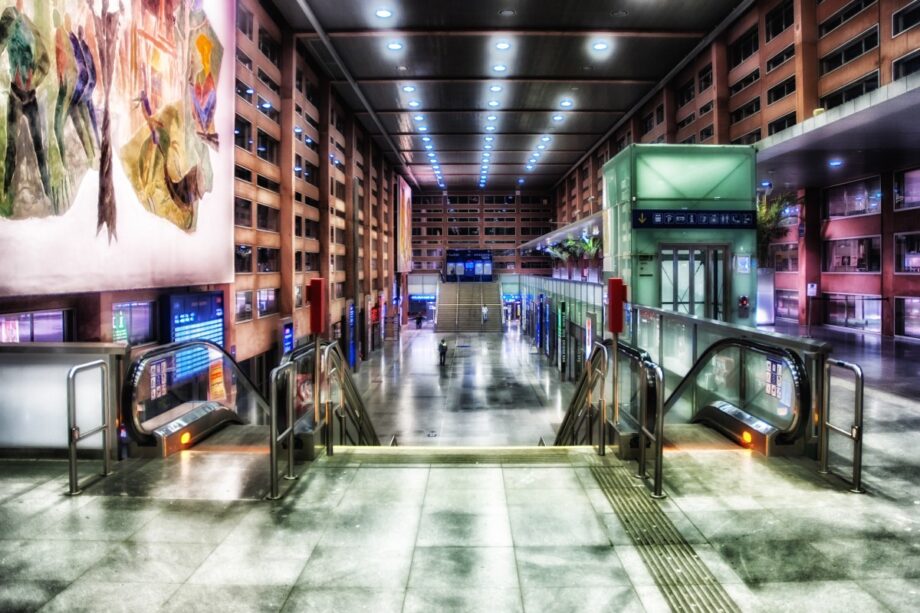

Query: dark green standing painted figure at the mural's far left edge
[0,0,51,217]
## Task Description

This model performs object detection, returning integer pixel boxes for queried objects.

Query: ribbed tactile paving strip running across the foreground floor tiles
[591,466,741,612]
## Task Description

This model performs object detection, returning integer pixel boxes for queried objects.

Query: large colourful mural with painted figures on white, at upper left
[0,0,235,295]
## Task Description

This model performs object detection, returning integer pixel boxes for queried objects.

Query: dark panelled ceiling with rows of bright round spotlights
[274,0,739,190]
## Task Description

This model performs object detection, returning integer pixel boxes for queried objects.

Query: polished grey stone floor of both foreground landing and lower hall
[0,322,920,612]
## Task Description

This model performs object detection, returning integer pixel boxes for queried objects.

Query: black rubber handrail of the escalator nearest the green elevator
[664,337,811,438]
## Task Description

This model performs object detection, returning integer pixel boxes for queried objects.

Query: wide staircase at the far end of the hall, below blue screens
[435,282,502,332]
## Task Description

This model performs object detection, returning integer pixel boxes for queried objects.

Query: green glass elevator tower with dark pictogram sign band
[604,145,757,326]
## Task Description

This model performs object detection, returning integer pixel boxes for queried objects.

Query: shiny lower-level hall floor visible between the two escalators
[356,327,573,446]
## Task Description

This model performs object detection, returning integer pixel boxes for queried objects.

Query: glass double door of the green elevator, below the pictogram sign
[658,245,729,320]
